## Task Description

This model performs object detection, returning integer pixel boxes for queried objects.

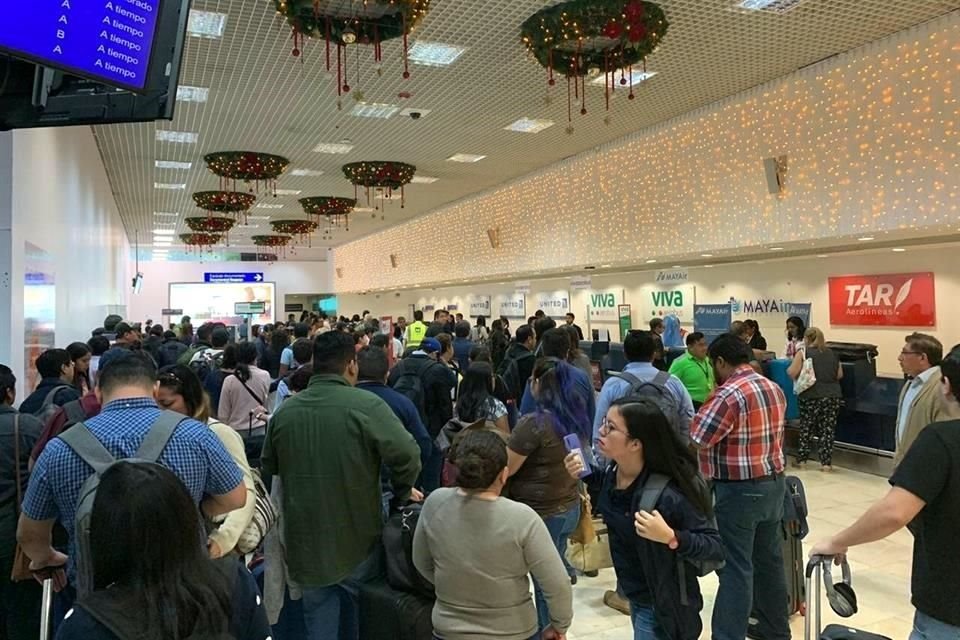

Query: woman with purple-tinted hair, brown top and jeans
[507,358,592,631]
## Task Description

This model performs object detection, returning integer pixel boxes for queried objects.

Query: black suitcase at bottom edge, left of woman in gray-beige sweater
[360,582,433,640]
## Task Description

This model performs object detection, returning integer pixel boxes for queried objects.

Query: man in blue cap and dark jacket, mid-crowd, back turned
[388,338,457,492]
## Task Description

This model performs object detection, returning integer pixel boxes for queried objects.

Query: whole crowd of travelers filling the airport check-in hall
[0,309,960,640]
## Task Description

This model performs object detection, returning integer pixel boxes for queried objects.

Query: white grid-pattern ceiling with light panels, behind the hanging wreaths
[95,0,960,260]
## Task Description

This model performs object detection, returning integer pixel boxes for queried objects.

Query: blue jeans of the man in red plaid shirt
[712,474,790,640]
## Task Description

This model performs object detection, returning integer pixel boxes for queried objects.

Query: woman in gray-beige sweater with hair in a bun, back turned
[413,430,573,640]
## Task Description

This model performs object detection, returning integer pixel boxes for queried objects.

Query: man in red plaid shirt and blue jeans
[690,334,790,640]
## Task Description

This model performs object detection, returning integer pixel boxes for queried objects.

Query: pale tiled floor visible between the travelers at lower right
[567,468,914,640]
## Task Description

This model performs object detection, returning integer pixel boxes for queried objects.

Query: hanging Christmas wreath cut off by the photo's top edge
[273,0,430,47]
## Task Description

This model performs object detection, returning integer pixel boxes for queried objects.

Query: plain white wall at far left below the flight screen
[0,127,130,396]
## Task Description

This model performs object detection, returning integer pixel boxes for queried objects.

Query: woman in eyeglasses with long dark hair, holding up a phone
[565,398,724,640]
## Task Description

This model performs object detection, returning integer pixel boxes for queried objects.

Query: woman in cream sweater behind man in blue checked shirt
[157,365,257,558]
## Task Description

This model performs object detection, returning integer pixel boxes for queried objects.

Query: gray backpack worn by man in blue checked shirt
[59,411,187,597]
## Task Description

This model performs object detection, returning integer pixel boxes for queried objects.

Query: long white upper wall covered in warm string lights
[333,12,960,293]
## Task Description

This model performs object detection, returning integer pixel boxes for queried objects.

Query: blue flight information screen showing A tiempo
[0,0,161,91]
